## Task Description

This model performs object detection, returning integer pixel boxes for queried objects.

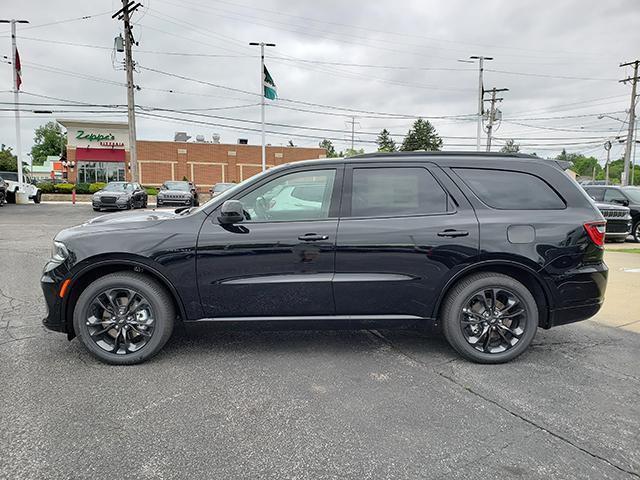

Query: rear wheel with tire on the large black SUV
[440,272,538,363]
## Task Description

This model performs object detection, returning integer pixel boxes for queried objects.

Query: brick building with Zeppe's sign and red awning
[58,120,326,190]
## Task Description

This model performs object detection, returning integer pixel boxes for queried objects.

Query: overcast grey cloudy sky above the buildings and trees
[0,0,640,165]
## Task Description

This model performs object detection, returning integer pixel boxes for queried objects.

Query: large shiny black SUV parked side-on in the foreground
[42,152,607,364]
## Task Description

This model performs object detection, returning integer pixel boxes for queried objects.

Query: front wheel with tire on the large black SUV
[73,272,176,365]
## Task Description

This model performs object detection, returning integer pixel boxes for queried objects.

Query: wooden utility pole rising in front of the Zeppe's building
[111,0,142,182]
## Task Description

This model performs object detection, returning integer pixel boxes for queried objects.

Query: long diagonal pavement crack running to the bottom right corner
[368,330,640,479]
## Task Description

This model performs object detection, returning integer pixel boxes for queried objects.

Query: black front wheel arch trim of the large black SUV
[62,257,187,339]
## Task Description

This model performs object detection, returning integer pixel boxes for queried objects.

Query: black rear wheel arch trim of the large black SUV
[433,260,553,328]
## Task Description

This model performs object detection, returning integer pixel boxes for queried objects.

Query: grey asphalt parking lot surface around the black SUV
[0,203,640,479]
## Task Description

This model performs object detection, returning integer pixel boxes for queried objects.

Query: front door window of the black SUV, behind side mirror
[238,170,336,222]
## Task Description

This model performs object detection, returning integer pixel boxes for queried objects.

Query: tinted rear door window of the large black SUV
[351,167,448,217]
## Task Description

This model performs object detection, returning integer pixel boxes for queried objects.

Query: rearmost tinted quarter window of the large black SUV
[455,168,566,210]
